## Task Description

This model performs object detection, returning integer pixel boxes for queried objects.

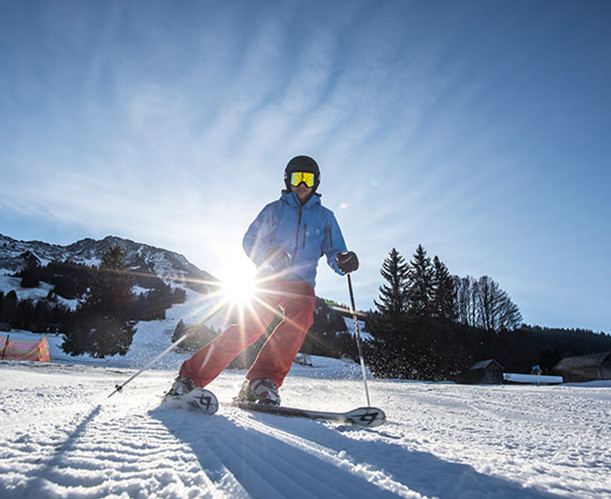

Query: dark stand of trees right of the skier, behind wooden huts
[366,245,611,381]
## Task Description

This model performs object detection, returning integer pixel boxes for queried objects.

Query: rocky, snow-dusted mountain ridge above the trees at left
[0,234,218,293]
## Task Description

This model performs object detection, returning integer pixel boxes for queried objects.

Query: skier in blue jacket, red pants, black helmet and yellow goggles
[168,156,359,405]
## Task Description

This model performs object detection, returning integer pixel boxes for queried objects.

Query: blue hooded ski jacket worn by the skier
[243,191,346,286]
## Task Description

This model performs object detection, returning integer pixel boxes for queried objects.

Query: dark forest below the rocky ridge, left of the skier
[0,246,186,358]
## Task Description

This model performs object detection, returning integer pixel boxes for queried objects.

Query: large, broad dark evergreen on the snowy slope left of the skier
[62,246,135,358]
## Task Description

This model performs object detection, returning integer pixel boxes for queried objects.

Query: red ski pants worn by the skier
[180,279,316,387]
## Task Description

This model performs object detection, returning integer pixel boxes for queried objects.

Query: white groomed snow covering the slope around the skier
[0,293,611,498]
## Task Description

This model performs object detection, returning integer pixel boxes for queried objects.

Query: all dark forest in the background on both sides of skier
[0,245,611,381]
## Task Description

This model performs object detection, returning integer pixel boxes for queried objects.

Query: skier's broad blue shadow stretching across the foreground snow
[149,407,557,499]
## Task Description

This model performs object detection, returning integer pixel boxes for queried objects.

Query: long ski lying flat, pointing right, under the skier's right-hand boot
[233,402,386,428]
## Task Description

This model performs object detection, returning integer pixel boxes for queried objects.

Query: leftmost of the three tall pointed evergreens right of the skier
[373,248,409,338]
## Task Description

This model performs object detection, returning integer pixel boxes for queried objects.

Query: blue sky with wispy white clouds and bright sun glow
[0,0,611,332]
